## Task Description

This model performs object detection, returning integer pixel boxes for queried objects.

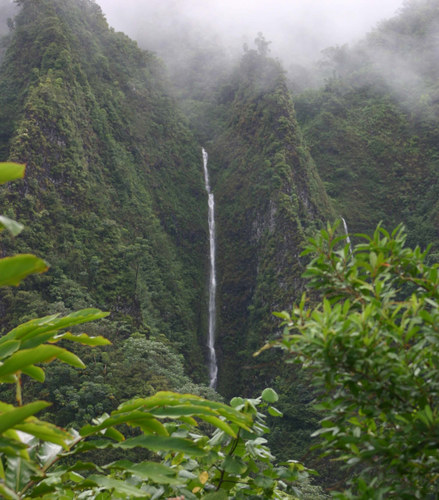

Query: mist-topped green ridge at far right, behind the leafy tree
[295,0,439,249]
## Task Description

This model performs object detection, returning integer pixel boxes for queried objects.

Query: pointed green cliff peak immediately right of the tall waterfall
[211,51,331,394]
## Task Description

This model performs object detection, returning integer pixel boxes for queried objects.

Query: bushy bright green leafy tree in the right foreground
[266,225,439,499]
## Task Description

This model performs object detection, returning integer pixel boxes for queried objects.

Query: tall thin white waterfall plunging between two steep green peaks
[203,148,218,387]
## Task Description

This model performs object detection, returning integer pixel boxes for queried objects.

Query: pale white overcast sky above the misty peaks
[96,0,403,62]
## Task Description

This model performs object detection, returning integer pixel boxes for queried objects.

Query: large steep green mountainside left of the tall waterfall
[0,0,208,381]
